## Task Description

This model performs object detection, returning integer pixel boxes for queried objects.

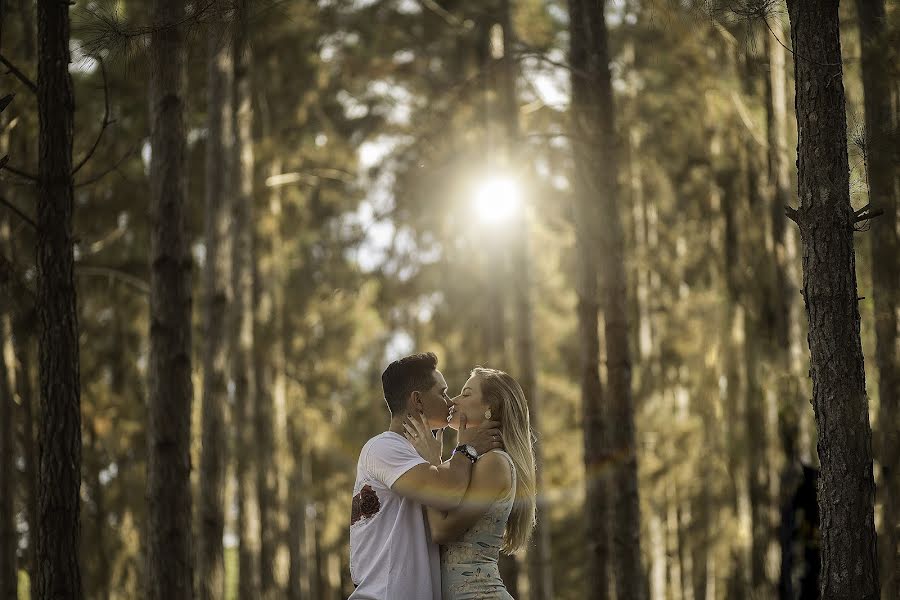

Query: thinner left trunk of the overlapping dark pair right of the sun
[569,0,612,600]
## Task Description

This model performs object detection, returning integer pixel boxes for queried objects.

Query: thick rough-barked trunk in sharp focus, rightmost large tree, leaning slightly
[788,0,879,600]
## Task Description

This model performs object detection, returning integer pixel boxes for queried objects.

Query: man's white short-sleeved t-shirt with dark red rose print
[350,431,441,600]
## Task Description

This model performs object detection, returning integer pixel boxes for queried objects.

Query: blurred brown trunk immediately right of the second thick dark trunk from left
[197,14,234,600]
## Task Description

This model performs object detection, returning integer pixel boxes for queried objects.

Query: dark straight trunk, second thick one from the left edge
[146,0,194,600]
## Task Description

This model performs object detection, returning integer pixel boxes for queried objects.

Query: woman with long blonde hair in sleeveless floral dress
[406,367,535,600]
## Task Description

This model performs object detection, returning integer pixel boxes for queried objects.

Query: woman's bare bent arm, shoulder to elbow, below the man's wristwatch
[427,452,512,544]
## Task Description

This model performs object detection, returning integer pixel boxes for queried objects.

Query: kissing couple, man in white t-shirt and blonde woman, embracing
[350,352,536,600]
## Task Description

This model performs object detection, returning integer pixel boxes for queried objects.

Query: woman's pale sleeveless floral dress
[441,450,516,600]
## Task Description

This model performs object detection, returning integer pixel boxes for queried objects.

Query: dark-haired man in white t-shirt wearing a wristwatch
[350,352,502,600]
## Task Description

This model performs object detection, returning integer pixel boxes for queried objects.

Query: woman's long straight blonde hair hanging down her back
[472,367,537,554]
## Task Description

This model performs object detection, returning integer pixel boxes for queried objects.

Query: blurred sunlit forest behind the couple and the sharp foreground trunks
[0,0,900,600]
